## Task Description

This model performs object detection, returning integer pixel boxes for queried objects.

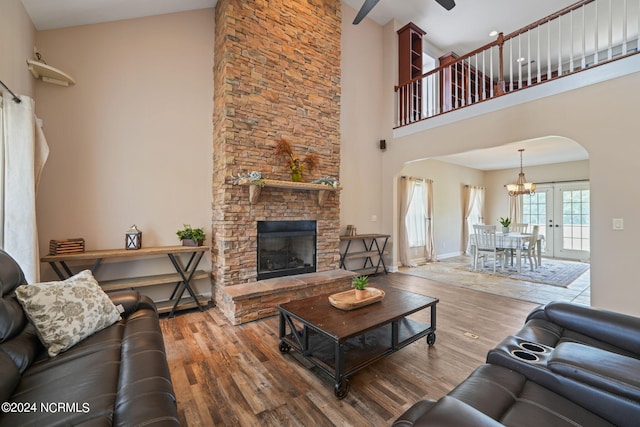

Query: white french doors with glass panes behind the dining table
[523,182,591,261]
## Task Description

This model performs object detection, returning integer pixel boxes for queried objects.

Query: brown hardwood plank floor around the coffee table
[160,274,537,426]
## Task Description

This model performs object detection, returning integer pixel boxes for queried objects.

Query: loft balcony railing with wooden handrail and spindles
[395,0,640,127]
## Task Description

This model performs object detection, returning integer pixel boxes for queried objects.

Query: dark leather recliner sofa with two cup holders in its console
[394,302,640,426]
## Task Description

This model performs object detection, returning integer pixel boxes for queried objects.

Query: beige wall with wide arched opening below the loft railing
[380,55,640,315]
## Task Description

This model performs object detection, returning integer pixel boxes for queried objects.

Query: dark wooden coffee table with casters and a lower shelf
[277,287,438,399]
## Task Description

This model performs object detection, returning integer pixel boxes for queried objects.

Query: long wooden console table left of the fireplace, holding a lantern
[40,246,209,317]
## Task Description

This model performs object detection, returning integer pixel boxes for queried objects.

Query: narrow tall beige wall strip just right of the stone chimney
[340,3,390,233]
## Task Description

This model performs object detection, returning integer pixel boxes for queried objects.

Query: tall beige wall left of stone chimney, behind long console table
[33,9,214,298]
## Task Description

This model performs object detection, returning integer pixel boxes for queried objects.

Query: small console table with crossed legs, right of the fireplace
[340,234,390,274]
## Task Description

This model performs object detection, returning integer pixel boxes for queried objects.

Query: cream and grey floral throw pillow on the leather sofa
[16,270,120,357]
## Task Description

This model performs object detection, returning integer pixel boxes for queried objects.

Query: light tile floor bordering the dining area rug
[399,256,591,305]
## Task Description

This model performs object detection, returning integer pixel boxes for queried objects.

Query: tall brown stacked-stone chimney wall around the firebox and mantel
[212,0,342,299]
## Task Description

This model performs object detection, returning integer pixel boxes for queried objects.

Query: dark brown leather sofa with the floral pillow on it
[0,251,180,427]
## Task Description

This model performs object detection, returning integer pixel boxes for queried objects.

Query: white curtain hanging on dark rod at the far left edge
[0,92,49,283]
